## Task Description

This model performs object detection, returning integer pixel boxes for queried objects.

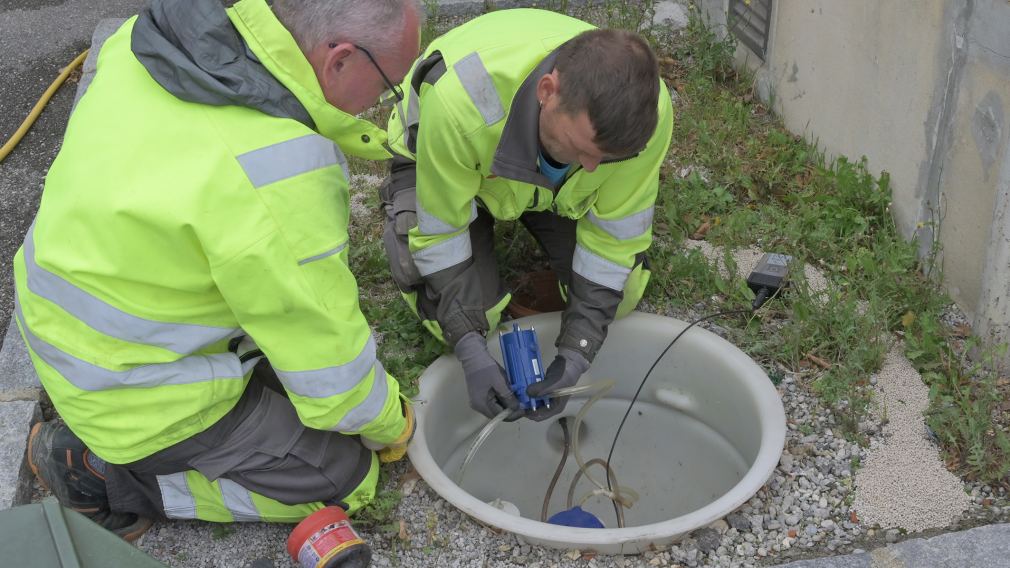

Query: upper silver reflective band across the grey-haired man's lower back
[24,222,241,355]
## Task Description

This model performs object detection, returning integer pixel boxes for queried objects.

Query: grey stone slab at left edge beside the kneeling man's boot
[0,400,42,510]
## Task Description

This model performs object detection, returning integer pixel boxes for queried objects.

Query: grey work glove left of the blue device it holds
[453,332,519,418]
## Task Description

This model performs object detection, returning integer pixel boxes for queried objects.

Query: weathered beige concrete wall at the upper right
[700,0,1010,357]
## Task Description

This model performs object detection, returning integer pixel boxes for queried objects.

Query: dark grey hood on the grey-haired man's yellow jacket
[131,0,315,129]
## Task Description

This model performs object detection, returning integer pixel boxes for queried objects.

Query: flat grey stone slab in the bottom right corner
[781,524,1010,568]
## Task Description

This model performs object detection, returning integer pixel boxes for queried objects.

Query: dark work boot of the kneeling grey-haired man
[28,420,150,541]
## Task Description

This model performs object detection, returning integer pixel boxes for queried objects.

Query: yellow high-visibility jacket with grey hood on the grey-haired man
[14,0,405,463]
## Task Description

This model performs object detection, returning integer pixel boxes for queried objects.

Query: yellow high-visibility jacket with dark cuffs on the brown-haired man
[389,9,673,353]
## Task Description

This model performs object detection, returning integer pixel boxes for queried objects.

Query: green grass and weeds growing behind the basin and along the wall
[341,0,1010,483]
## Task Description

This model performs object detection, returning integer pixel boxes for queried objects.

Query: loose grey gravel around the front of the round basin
[124,276,1010,568]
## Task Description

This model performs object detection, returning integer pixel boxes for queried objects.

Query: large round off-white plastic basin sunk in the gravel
[409,312,786,554]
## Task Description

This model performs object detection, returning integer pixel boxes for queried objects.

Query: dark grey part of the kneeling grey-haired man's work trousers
[106,359,372,518]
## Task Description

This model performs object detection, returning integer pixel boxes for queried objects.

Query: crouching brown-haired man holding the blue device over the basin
[382,9,673,420]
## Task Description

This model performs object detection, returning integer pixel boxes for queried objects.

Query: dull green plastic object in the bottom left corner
[0,497,165,568]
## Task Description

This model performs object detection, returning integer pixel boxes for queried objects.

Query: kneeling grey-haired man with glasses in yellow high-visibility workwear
[14,0,423,539]
